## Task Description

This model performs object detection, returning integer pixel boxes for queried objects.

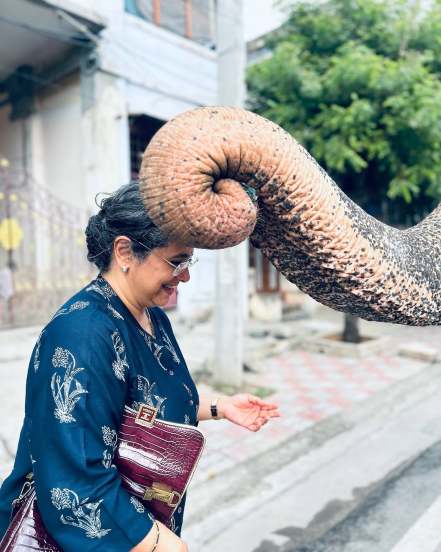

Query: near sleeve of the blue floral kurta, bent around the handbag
[27,312,154,552]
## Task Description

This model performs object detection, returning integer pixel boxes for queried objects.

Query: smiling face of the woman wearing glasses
[128,243,193,307]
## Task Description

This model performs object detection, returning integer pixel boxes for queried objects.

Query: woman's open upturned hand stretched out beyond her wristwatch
[217,393,280,431]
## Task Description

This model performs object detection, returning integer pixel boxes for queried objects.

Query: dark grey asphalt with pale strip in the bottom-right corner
[276,435,441,552]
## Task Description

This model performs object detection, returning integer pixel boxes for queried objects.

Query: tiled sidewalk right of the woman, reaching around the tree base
[175,311,441,488]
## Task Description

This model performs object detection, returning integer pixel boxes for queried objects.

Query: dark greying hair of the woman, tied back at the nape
[86,182,170,272]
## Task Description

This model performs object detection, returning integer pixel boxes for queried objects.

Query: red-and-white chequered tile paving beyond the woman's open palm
[190,351,430,486]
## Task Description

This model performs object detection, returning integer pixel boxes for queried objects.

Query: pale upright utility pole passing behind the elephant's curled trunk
[214,0,248,387]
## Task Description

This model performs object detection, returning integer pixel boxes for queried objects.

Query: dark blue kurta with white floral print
[0,276,199,552]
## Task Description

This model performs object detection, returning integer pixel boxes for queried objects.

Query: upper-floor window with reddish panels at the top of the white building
[125,0,215,49]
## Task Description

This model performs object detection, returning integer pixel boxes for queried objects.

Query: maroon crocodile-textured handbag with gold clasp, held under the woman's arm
[0,404,205,552]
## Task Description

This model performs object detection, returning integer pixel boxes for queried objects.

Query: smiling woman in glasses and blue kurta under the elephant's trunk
[0,184,279,552]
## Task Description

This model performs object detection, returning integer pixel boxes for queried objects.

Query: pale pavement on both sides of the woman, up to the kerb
[0,308,441,550]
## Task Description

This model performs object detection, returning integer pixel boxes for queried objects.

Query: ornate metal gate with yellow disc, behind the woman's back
[0,160,93,329]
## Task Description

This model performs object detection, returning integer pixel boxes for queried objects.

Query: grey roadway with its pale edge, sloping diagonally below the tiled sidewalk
[184,365,441,552]
